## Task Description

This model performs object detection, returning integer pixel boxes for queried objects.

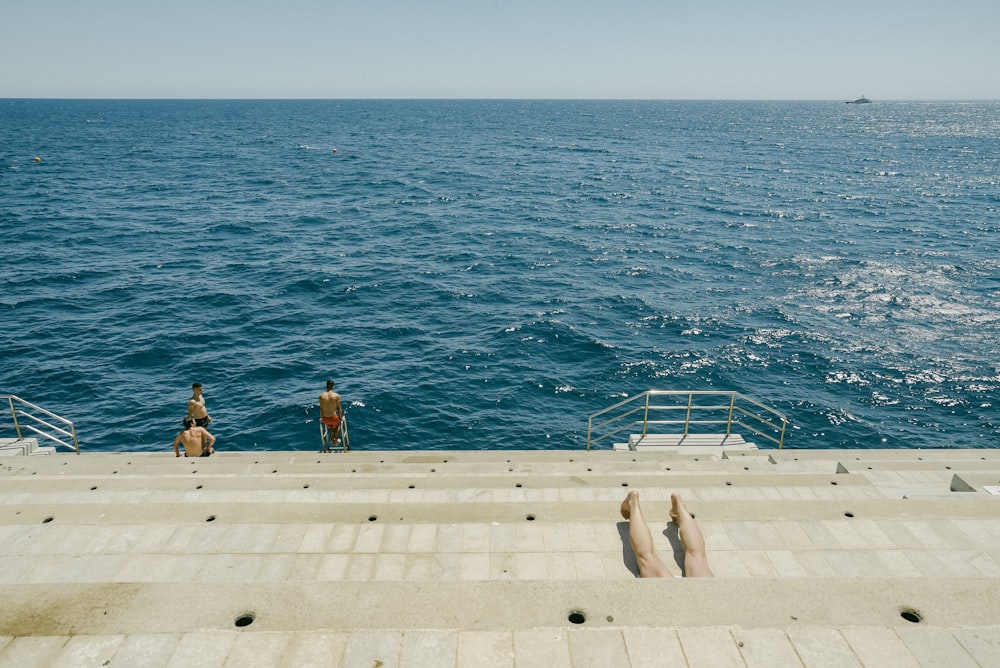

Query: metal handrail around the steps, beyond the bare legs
[587,390,788,450]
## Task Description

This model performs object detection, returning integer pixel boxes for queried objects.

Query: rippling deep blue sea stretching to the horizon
[0,100,1000,451]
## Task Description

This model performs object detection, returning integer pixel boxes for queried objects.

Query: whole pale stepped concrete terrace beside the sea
[0,441,1000,668]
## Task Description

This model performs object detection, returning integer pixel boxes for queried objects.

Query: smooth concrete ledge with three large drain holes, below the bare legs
[0,577,1000,635]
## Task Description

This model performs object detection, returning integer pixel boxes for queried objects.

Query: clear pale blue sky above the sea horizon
[0,0,1000,100]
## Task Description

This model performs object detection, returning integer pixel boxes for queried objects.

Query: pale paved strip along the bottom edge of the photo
[0,611,998,668]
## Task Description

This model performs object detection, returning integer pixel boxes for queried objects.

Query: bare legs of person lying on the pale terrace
[621,490,714,578]
